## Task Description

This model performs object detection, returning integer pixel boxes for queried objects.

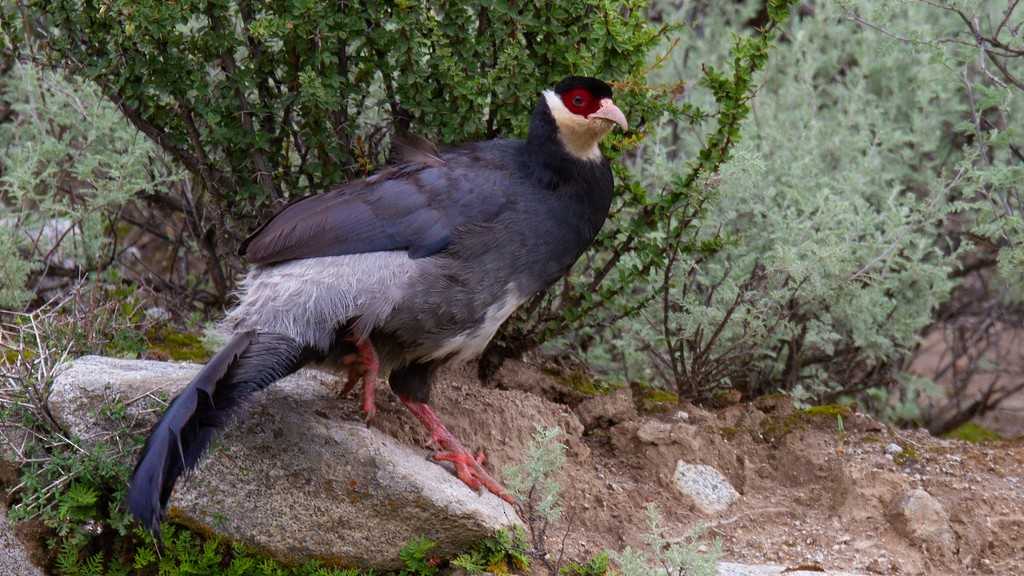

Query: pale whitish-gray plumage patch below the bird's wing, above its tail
[221,251,417,349]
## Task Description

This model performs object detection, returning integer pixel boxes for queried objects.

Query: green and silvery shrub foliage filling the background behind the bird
[0,0,1024,572]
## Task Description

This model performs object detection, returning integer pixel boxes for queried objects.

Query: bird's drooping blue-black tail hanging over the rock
[128,332,314,540]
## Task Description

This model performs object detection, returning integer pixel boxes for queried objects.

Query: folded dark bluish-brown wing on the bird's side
[239,149,509,264]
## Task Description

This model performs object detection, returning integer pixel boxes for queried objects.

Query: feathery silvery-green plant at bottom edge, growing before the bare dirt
[611,504,723,576]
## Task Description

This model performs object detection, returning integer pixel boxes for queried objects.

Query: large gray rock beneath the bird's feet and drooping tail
[49,357,519,569]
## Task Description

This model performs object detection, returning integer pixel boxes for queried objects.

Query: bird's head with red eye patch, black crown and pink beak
[544,76,629,161]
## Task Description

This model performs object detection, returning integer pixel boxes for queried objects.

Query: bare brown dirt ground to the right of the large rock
[376,362,1024,575]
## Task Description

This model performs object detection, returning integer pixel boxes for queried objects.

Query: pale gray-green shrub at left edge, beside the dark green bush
[0,64,179,310]
